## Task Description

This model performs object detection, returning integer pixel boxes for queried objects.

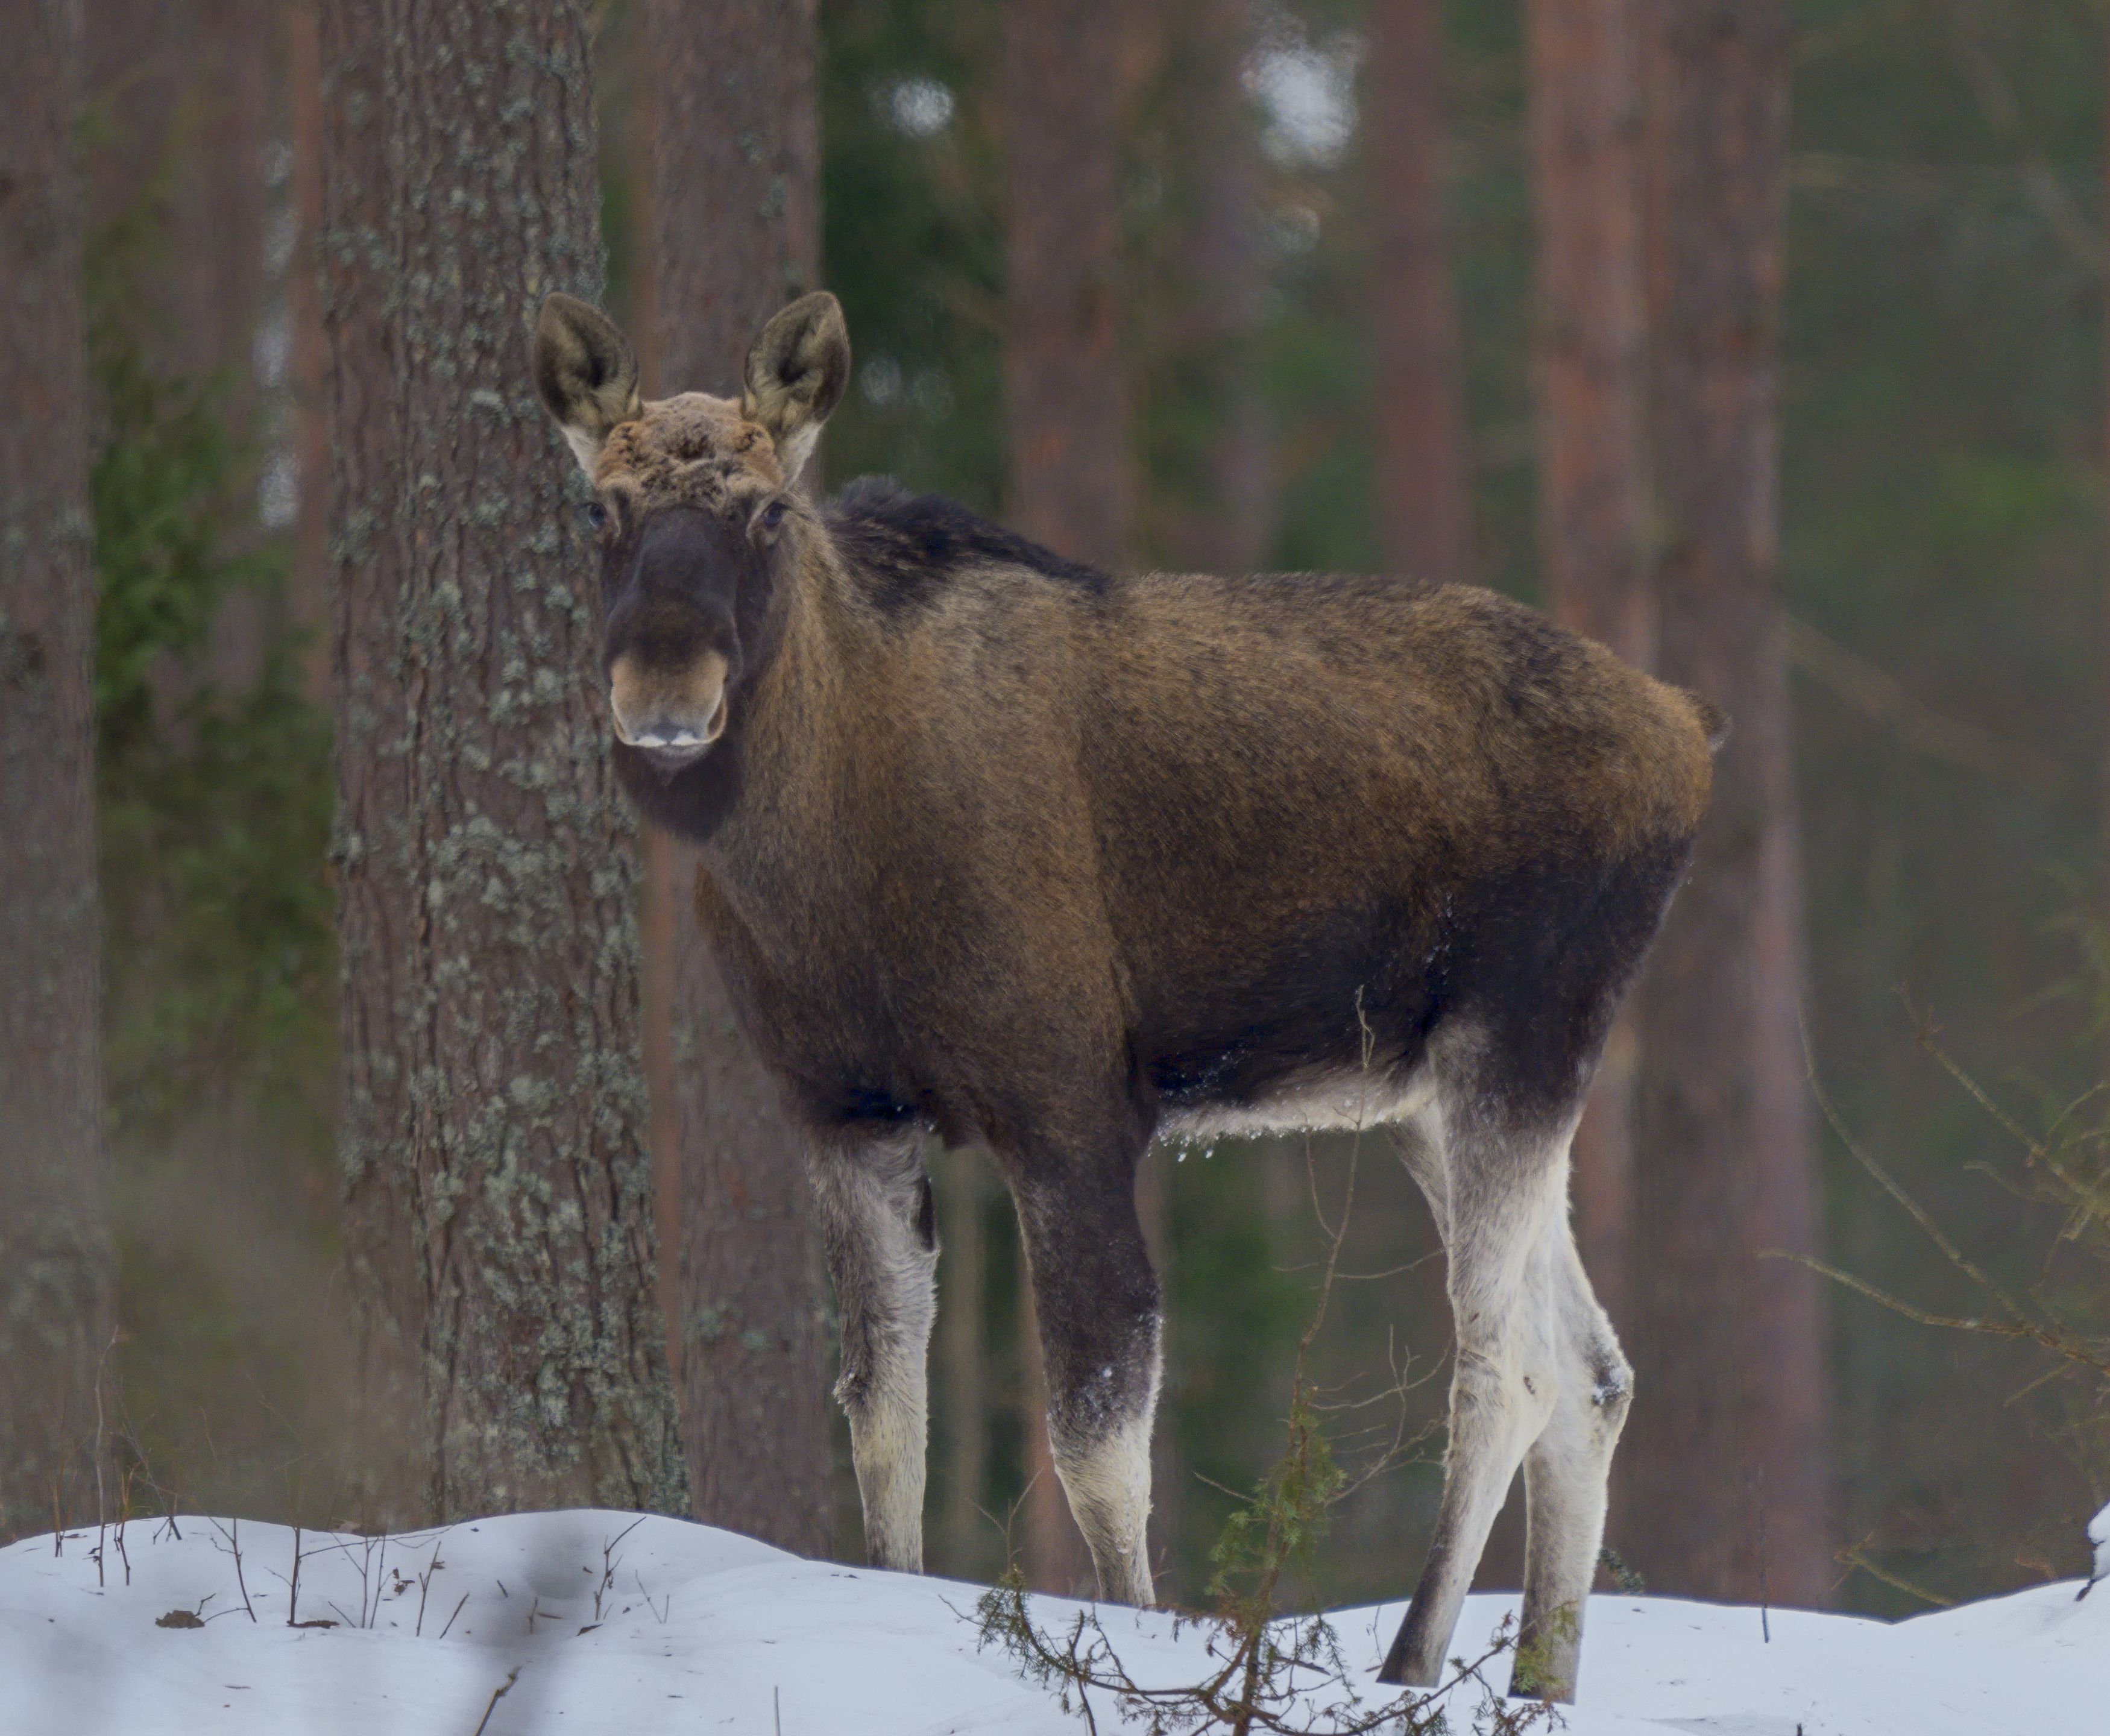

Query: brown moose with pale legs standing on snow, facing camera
[534,295,1720,1696]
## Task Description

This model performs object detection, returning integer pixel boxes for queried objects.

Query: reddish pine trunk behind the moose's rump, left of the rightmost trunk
[1526,0,1657,1322]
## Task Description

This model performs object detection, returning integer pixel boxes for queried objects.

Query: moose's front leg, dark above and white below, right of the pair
[1013,1162,1160,1608]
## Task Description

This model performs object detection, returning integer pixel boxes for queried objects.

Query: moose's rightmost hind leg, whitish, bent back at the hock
[1509,1219,1633,1700]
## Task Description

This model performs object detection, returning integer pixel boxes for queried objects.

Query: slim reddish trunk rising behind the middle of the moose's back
[1365,0,1473,578]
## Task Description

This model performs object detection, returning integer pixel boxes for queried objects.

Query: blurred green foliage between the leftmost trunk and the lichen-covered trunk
[84,162,336,1128]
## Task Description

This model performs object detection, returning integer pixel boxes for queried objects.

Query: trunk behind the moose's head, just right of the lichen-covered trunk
[644,0,834,1555]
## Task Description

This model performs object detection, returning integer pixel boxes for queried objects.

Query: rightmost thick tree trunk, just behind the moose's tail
[1619,0,1831,1603]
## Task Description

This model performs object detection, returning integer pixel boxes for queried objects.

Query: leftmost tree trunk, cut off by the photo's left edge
[0,0,112,1542]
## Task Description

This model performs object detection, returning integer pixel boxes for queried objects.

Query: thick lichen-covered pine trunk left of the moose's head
[321,0,688,1521]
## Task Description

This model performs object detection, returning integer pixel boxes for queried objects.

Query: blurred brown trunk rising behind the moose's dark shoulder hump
[1003,0,1133,1593]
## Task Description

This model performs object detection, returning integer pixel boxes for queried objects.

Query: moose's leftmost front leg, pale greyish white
[810,1139,937,1574]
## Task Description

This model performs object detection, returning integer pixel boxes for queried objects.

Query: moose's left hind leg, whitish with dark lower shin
[1378,1127,1566,1688]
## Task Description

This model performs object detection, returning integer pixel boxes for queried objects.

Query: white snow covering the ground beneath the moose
[0,1511,2110,1736]
